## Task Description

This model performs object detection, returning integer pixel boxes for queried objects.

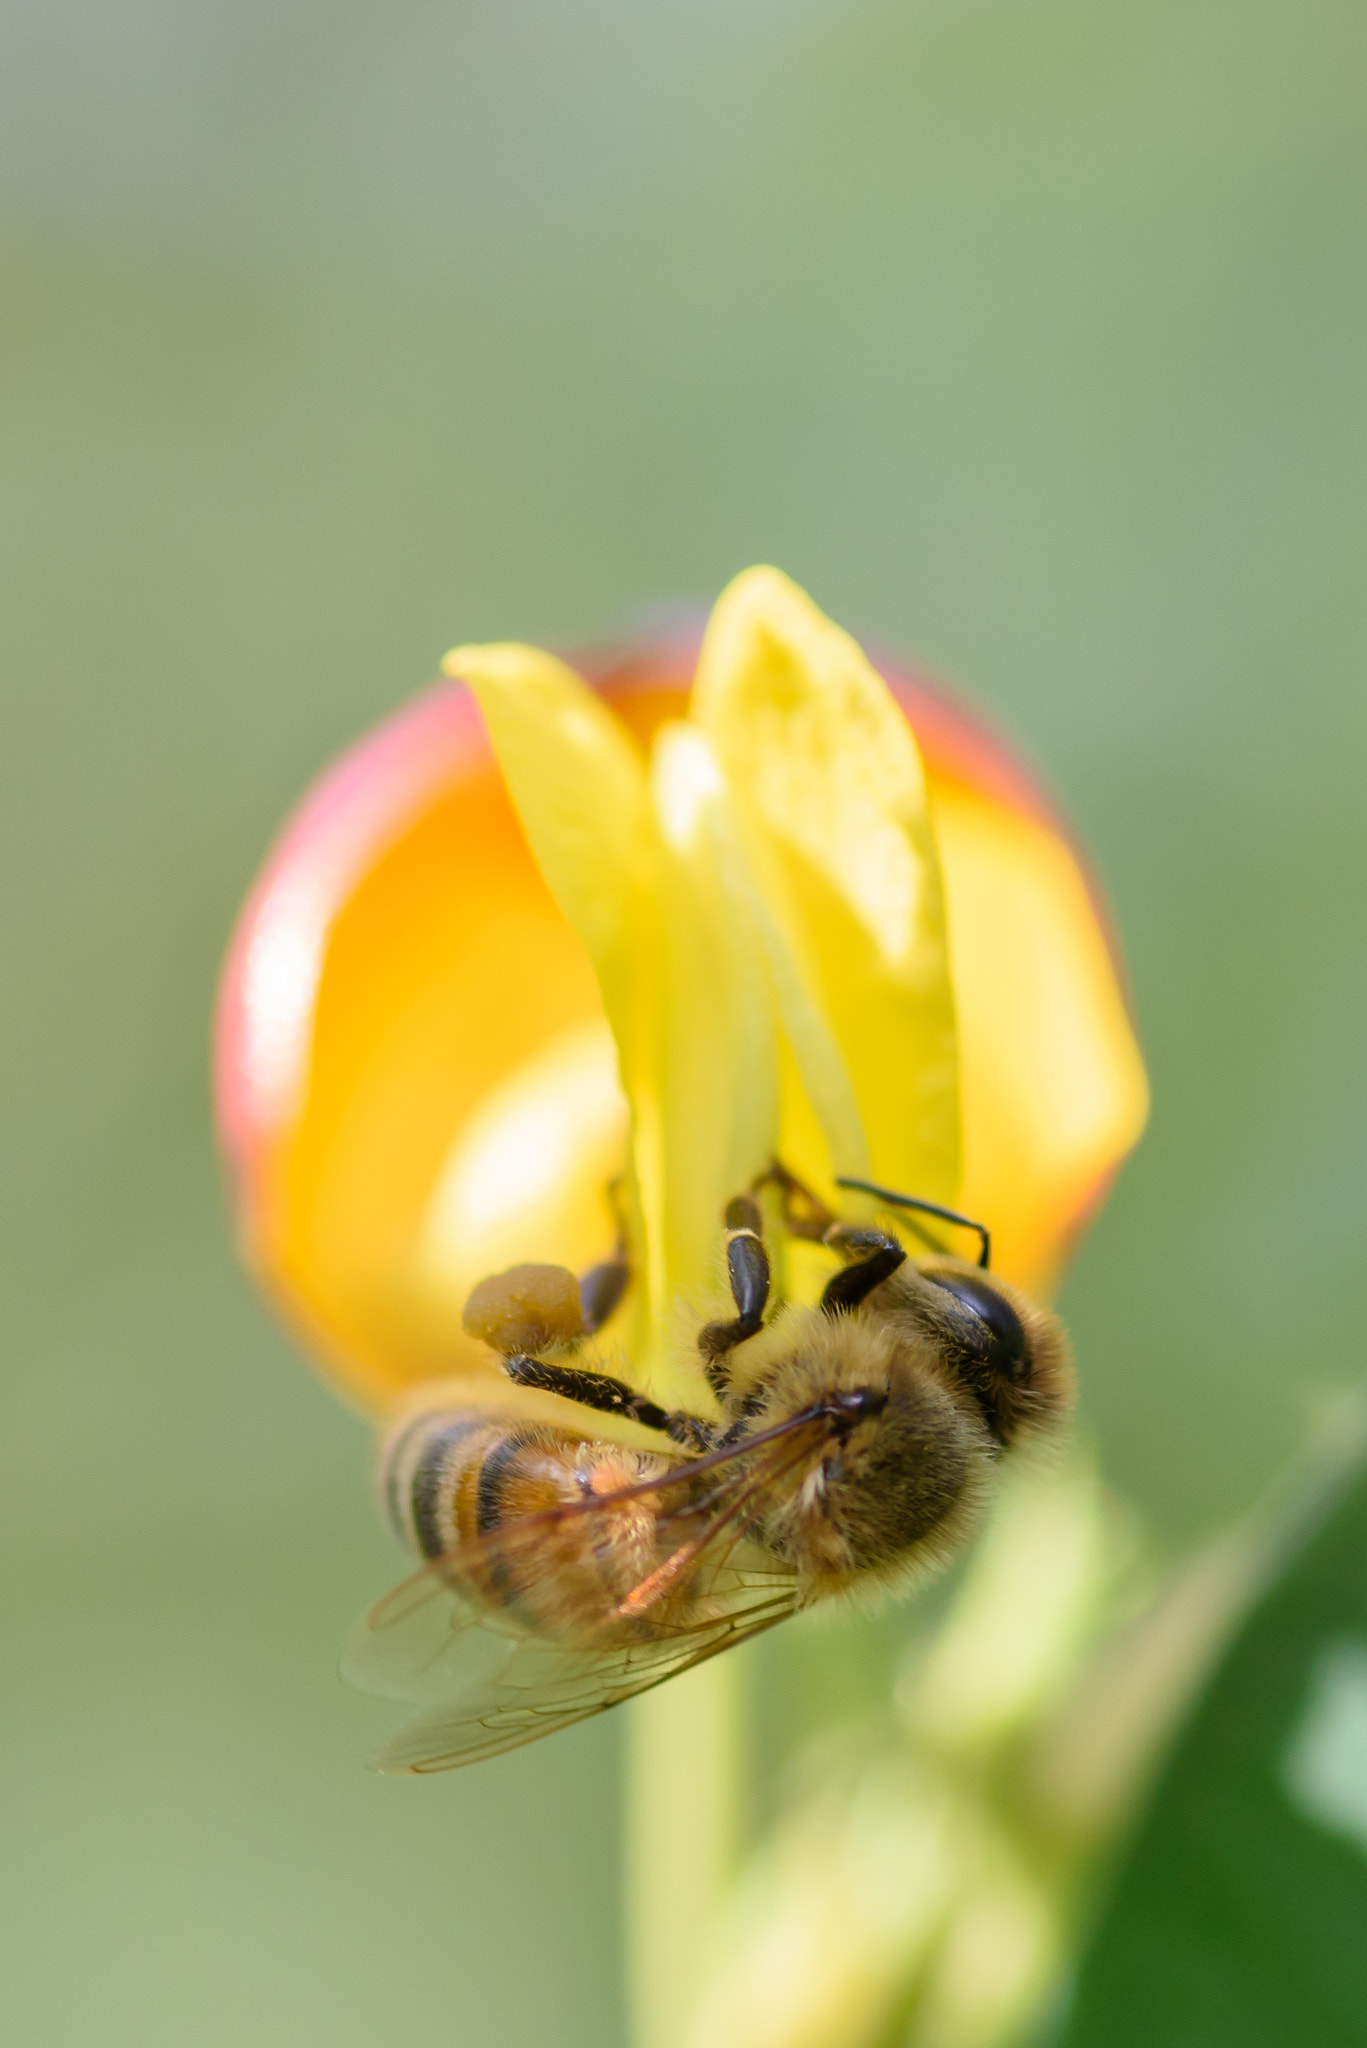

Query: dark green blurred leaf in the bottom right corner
[1058,1458,1367,2048]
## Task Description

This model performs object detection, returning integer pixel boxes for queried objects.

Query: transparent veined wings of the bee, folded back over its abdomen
[342,1415,828,1772]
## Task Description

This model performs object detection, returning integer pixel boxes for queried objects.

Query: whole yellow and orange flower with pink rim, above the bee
[217,569,1146,1415]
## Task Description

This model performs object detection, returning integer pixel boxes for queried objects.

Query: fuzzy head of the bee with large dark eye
[916,1260,1072,1448]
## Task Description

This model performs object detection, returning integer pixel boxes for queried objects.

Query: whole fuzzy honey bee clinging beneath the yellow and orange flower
[344,1165,1072,1772]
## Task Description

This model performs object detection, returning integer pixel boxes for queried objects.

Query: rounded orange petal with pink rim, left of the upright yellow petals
[217,684,621,1407]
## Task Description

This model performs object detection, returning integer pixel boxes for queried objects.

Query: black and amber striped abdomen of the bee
[381,1409,685,1640]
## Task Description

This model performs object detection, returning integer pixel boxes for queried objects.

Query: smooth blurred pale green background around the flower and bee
[0,0,1367,2048]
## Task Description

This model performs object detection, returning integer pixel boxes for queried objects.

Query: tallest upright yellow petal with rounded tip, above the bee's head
[691,569,959,1200]
